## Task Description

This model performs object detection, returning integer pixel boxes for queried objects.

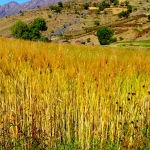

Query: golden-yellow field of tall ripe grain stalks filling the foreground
[0,38,150,150]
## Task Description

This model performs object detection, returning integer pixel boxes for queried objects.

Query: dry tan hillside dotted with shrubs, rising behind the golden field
[0,0,150,45]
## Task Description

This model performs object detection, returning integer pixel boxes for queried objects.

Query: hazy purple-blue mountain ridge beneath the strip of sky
[0,0,66,18]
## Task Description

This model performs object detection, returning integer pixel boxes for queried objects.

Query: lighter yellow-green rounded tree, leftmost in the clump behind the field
[10,20,29,39]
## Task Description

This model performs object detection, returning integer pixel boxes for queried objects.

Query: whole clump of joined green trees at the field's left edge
[10,18,48,41]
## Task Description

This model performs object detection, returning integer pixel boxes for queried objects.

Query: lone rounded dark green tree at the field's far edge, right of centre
[97,26,117,45]
